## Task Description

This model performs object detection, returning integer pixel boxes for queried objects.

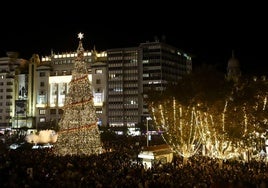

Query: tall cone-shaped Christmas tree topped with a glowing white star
[54,33,102,156]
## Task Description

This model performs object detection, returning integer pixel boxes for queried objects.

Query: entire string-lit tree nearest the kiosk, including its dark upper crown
[149,67,231,163]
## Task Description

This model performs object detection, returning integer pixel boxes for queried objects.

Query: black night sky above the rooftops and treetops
[0,1,268,74]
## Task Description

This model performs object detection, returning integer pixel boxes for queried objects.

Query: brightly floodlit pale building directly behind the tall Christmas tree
[36,50,107,129]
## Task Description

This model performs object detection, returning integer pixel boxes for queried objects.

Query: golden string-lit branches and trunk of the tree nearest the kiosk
[152,98,205,164]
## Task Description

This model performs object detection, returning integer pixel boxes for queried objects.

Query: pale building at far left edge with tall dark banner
[0,52,35,128]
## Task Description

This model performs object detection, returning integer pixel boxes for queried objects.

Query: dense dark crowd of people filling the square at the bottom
[0,134,268,188]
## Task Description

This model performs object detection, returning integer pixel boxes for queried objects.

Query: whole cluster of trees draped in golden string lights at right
[148,64,268,162]
